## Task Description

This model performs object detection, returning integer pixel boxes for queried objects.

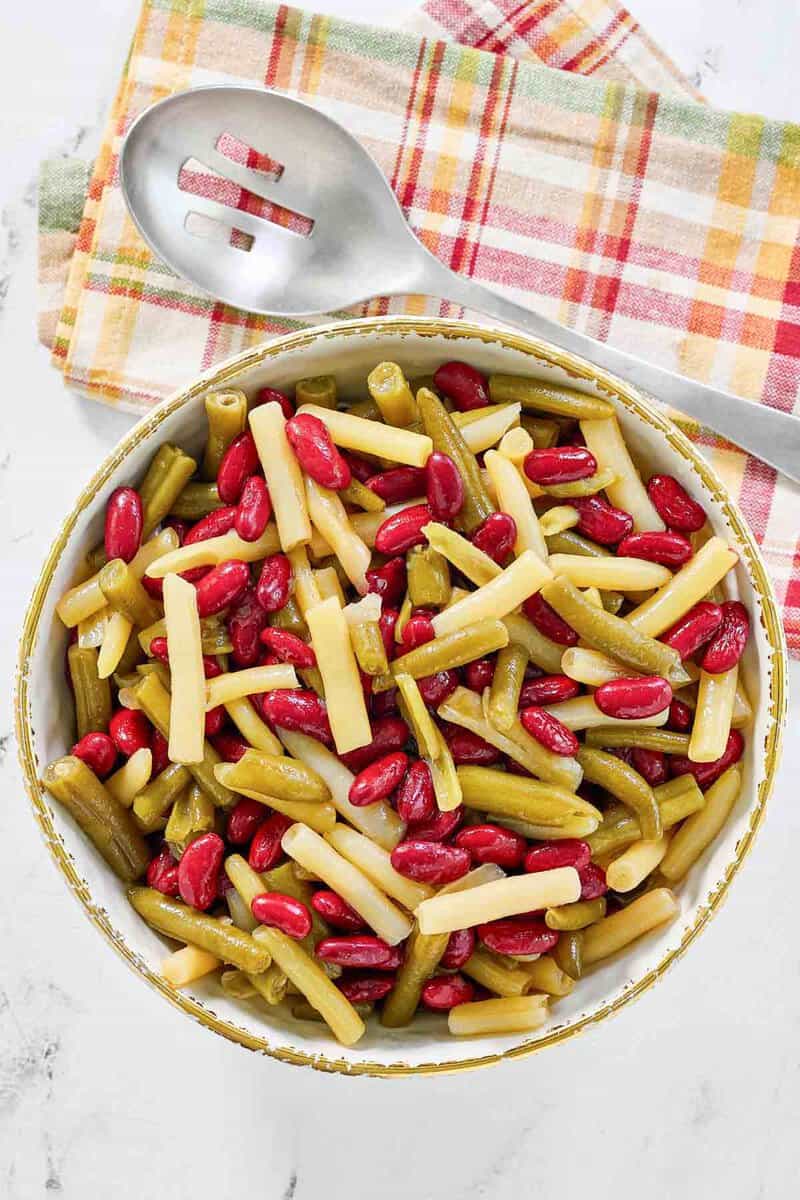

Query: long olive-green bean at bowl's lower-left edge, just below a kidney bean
[128,888,270,974]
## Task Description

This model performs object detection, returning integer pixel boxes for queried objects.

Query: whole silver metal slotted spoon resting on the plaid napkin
[120,86,800,482]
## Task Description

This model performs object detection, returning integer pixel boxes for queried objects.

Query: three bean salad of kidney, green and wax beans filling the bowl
[43,361,752,1045]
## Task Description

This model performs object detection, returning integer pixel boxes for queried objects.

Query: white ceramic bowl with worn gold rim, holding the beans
[17,317,786,1075]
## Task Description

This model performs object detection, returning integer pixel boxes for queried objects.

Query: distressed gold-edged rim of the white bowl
[14,316,788,1078]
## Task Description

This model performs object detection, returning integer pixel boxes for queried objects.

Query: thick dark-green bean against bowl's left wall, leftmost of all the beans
[42,755,150,883]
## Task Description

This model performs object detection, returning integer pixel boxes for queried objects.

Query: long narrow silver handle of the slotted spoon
[420,263,800,484]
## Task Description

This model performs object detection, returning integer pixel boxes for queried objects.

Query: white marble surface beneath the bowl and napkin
[0,0,800,1200]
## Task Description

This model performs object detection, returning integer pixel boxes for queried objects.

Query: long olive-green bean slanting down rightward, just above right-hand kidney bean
[541,576,688,686]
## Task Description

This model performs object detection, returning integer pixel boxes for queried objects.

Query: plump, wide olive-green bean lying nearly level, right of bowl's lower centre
[457,767,602,828]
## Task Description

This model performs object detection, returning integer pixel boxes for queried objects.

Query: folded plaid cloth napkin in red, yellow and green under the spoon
[41,0,800,653]
